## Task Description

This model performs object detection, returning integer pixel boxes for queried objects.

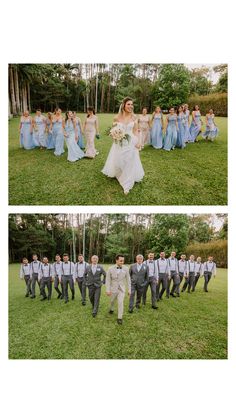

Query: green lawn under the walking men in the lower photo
[9,264,227,359]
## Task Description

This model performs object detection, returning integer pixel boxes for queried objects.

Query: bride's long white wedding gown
[102,121,144,193]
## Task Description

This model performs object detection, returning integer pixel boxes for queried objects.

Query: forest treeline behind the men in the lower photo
[9,214,228,267]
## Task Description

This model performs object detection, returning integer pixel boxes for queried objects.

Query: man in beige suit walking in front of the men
[106,255,131,324]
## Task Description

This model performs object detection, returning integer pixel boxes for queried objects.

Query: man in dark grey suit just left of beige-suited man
[84,255,106,317]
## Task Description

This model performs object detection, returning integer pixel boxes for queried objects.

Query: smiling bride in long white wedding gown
[102,97,144,194]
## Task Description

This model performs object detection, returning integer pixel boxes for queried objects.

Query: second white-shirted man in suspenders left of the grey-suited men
[59,253,75,304]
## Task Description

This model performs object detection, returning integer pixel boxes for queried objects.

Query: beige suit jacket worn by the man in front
[106,265,131,293]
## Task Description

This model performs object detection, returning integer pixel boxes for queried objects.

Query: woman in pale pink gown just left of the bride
[83,106,99,159]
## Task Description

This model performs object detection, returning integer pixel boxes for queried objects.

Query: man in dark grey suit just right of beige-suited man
[129,255,148,313]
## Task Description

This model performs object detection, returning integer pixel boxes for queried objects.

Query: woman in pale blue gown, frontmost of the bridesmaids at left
[64,111,84,162]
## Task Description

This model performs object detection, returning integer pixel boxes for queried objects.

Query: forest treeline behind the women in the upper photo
[9,64,228,116]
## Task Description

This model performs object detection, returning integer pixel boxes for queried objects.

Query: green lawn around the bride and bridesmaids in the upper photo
[9,114,227,205]
